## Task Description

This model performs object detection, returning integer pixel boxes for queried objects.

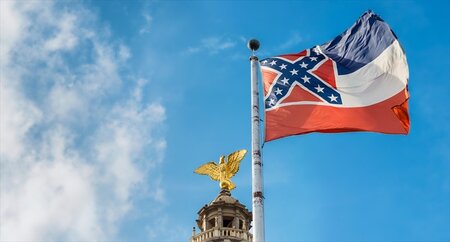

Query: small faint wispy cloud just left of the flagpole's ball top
[185,36,237,55]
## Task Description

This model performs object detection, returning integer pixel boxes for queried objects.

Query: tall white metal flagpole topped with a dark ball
[248,39,265,242]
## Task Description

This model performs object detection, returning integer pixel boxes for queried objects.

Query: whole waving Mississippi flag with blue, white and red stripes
[261,11,409,141]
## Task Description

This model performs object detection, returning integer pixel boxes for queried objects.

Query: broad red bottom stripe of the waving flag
[265,90,409,141]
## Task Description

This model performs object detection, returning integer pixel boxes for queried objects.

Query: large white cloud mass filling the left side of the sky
[0,1,165,241]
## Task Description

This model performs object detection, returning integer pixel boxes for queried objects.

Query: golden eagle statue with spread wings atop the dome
[194,149,247,191]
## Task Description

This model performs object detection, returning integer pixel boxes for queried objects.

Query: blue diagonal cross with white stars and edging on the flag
[261,47,342,109]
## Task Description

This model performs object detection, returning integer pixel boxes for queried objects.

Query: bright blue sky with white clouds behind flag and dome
[0,0,450,242]
